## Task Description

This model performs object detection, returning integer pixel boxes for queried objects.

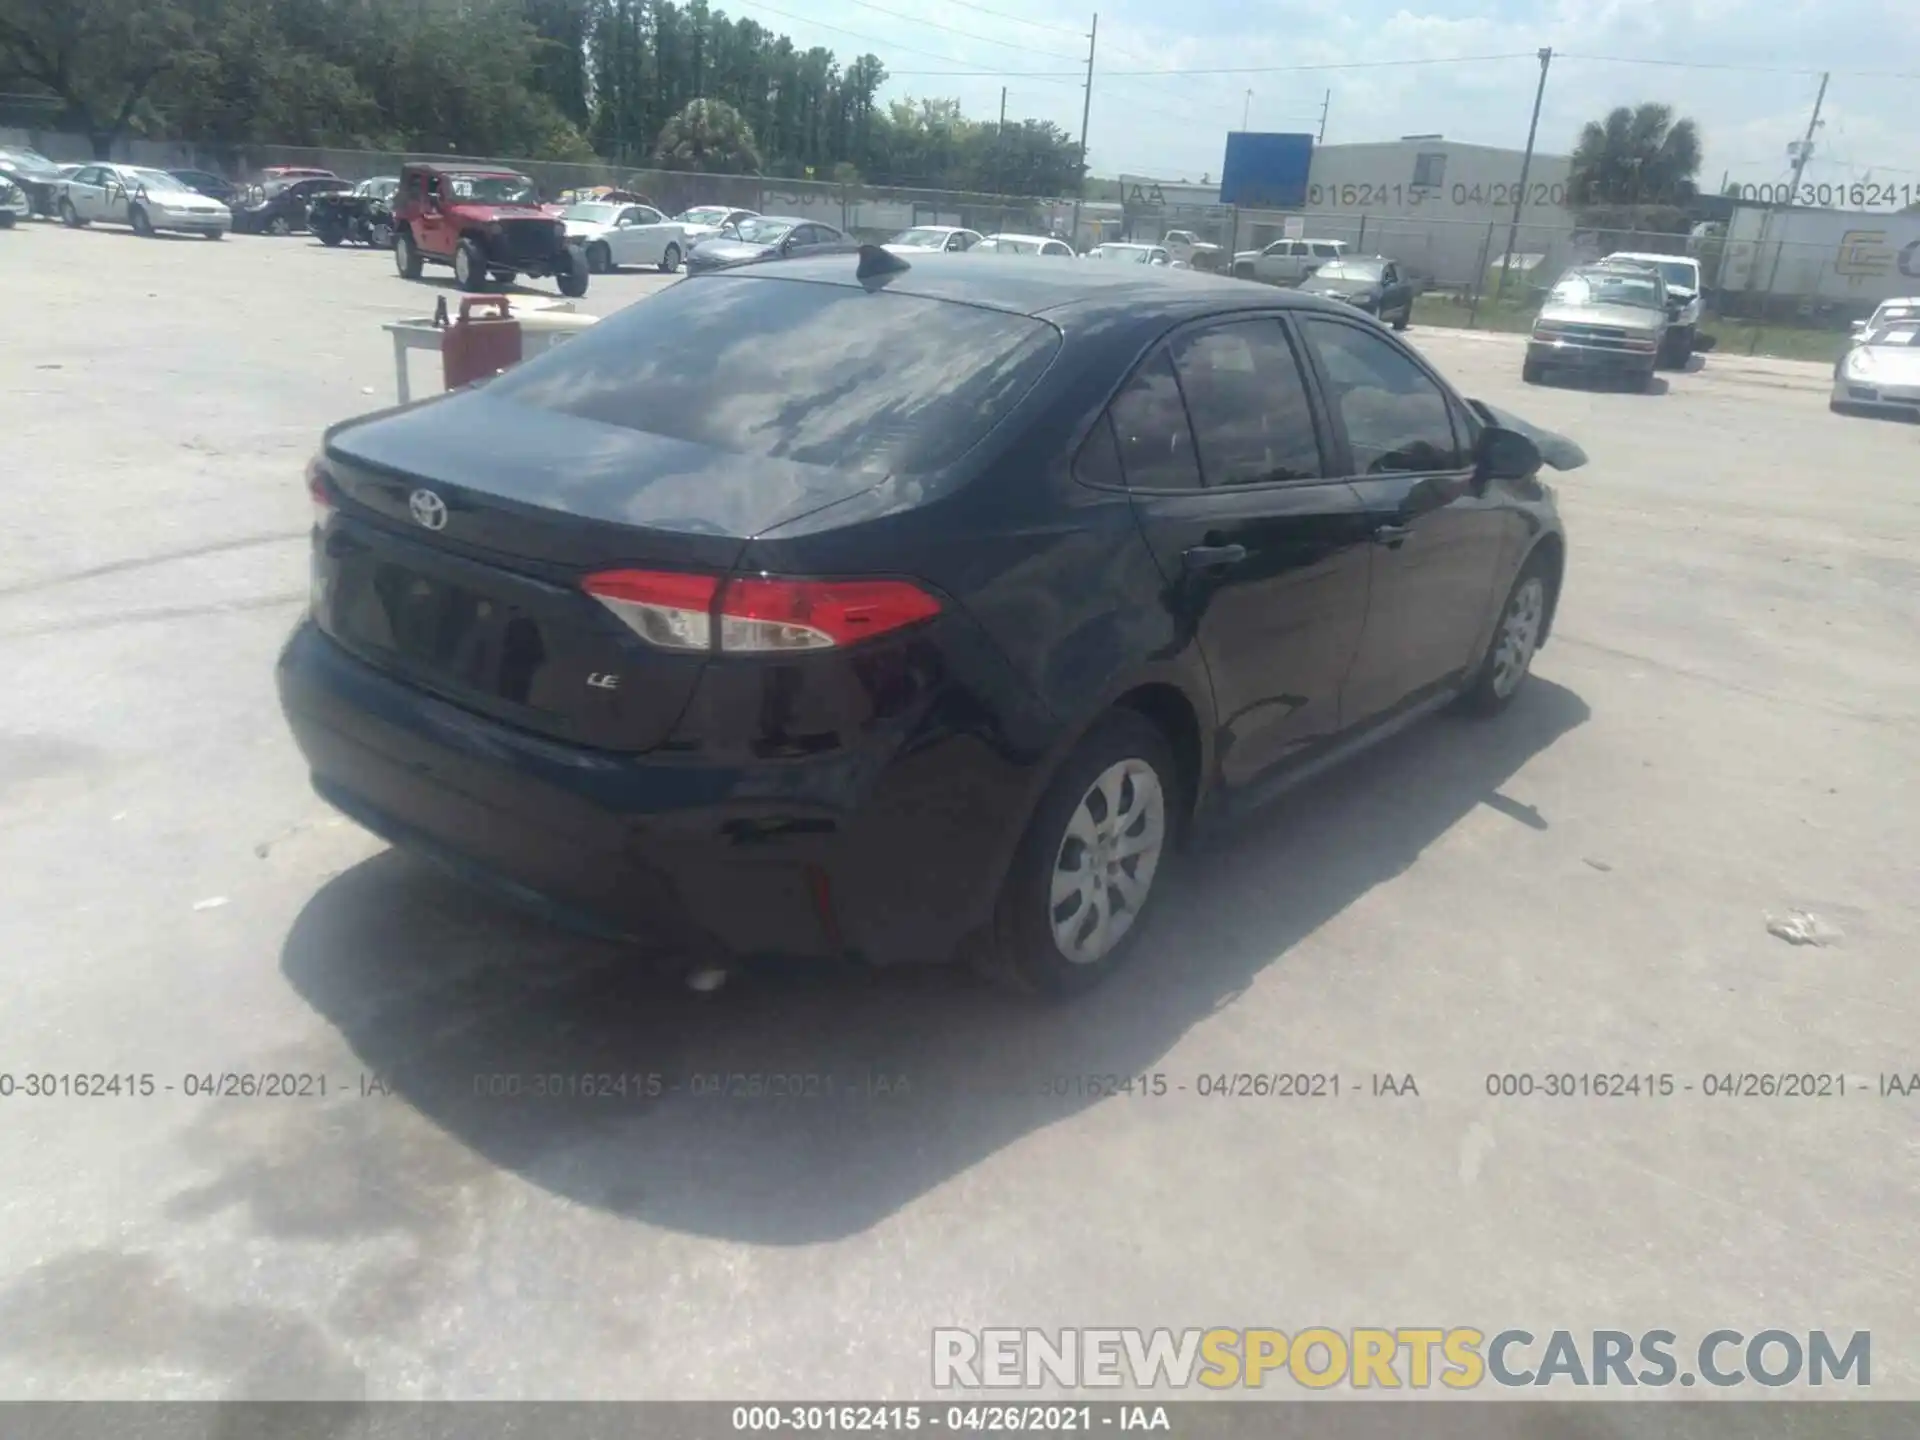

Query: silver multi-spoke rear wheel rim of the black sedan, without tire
[1046,758,1167,966]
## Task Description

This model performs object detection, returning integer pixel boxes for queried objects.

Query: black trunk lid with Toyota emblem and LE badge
[313,390,874,751]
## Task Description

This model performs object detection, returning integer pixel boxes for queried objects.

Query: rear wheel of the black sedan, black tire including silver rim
[975,710,1187,998]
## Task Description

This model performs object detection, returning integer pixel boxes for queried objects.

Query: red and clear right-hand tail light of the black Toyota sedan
[582,570,941,655]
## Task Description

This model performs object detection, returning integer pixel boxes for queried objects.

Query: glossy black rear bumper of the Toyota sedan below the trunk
[278,622,1020,962]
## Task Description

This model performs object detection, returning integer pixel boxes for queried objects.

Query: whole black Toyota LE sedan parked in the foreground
[278,248,1584,993]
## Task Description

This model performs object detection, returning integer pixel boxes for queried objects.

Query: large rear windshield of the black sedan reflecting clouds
[488,275,1060,474]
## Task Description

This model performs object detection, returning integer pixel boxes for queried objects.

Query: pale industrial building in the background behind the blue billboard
[1123,134,1572,286]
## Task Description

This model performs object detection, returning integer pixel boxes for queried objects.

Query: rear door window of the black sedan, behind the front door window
[1173,321,1325,486]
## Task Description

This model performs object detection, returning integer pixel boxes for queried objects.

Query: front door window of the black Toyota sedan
[1300,319,1461,474]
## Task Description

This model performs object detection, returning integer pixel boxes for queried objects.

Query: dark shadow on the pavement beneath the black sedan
[274,678,1588,1244]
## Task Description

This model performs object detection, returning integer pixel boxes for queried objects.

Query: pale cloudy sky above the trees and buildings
[716,0,1920,198]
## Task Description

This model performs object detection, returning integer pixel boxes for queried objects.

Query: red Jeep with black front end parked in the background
[394,165,588,296]
